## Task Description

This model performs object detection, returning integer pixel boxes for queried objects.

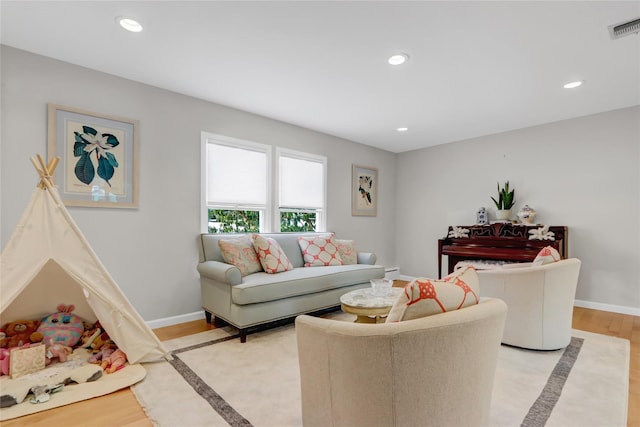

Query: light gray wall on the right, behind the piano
[396,107,640,315]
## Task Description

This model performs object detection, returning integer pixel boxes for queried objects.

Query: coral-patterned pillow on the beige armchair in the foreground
[386,266,480,322]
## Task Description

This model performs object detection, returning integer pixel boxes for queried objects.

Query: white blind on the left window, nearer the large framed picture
[207,142,268,206]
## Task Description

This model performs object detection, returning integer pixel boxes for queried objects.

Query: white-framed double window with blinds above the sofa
[202,132,327,233]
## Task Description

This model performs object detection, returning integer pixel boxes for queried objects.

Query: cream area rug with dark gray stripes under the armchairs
[132,312,629,427]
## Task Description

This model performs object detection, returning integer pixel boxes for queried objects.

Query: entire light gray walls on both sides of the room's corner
[0,46,640,320]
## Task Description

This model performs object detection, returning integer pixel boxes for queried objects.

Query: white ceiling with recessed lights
[0,0,640,152]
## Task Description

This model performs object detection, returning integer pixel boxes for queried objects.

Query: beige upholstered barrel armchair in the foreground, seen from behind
[296,299,507,427]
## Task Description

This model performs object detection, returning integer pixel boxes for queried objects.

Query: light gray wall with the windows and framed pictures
[0,46,396,321]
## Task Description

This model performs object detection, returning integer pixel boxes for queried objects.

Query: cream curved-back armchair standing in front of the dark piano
[478,258,581,350]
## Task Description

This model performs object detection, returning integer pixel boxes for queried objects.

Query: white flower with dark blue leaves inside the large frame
[73,126,120,187]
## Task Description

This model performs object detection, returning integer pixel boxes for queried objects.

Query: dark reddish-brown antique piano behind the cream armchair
[438,222,568,277]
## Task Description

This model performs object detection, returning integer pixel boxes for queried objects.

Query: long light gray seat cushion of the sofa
[231,264,385,309]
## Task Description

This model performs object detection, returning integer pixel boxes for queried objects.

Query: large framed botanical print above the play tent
[47,104,139,208]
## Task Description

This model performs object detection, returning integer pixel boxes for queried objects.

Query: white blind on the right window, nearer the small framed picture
[279,154,324,209]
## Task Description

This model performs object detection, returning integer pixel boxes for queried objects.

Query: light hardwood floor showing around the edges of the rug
[0,307,640,427]
